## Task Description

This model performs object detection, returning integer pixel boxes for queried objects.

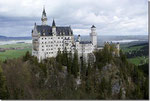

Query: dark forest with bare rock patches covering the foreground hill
[0,44,149,100]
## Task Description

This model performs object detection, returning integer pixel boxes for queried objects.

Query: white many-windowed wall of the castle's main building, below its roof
[32,31,73,59]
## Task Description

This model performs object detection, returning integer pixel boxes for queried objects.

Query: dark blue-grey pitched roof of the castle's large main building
[36,25,73,36]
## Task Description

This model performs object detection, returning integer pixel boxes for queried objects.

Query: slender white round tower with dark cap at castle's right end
[90,25,97,49]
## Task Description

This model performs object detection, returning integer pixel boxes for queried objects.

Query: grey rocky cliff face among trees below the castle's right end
[99,63,126,99]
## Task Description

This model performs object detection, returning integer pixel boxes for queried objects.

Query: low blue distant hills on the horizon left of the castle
[0,35,32,41]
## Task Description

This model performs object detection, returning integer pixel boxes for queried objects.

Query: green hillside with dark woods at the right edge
[122,42,149,66]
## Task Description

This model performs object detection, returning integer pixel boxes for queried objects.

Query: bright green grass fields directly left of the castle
[0,43,32,61]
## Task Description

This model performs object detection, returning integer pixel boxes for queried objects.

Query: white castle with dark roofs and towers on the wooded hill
[32,8,119,61]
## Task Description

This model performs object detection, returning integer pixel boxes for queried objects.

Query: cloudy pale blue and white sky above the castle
[0,0,148,37]
